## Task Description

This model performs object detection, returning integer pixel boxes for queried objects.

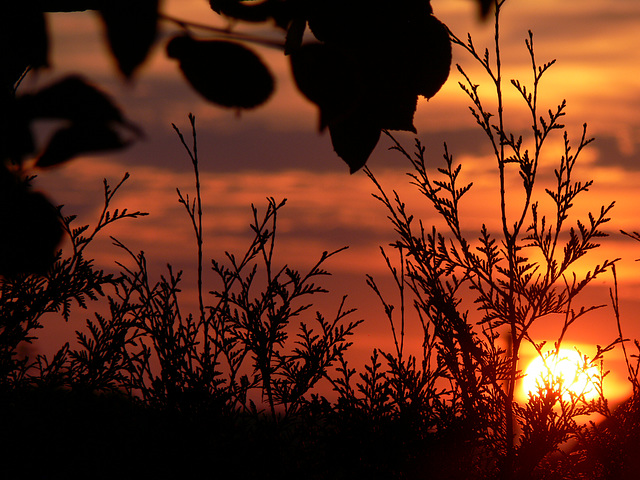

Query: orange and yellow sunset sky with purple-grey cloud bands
[25,0,640,399]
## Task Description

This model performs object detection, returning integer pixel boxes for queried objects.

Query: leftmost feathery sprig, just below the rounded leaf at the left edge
[0,174,147,388]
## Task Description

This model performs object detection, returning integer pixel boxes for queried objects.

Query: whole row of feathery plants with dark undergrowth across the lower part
[0,1,640,479]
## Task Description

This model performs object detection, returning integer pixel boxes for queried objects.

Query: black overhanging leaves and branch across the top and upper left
[0,0,492,275]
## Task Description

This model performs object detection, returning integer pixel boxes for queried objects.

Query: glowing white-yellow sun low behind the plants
[522,349,598,401]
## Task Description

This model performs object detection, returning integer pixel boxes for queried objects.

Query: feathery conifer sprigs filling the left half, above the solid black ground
[0,110,362,426]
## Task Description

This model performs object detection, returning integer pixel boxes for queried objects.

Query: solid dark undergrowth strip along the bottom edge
[0,388,640,480]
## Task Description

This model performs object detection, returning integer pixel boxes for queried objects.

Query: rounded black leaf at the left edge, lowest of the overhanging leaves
[0,172,63,276]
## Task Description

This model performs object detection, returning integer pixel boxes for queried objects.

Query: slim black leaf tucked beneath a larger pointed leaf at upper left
[36,123,130,168]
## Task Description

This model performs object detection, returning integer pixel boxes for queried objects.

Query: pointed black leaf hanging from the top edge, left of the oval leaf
[100,0,158,77]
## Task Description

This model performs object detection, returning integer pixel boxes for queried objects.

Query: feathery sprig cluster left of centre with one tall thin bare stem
[74,115,361,418]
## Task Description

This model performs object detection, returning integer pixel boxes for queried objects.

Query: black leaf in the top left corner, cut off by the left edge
[0,6,49,88]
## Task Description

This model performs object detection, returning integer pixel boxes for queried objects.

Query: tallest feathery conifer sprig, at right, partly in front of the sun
[365,1,618,478]
